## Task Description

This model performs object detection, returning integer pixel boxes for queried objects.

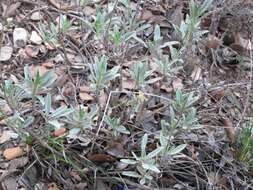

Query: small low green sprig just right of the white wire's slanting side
[105,116,130,137]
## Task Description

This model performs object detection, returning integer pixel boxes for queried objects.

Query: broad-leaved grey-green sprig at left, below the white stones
[22,66,56,98]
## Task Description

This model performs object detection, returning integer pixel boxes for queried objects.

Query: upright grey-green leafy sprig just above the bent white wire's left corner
[89,56,120,94]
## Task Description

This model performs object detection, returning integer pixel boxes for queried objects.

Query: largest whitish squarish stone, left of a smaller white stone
[13,28,28,47]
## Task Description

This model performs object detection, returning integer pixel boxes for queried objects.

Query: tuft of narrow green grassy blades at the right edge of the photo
[237,120,253,167]
